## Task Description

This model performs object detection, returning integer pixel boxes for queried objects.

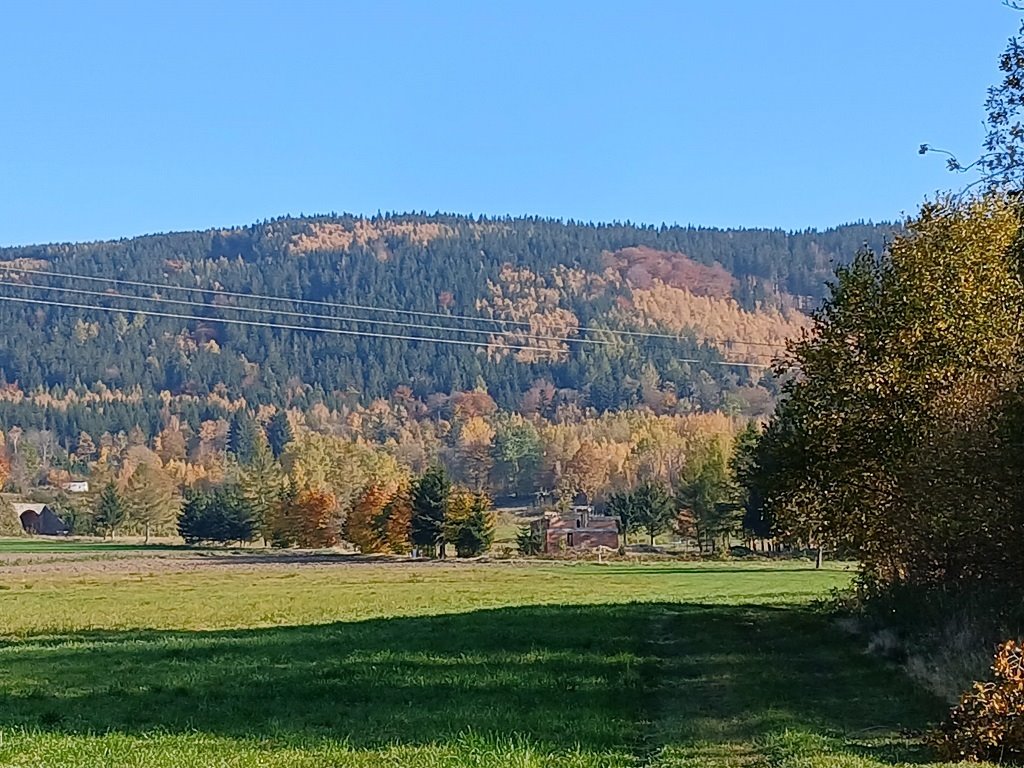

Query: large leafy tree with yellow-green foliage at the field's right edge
[758,196,1024,590]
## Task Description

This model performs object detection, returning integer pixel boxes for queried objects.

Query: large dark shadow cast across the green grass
[0,603,941,759]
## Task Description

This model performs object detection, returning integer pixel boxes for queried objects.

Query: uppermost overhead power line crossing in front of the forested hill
[2,266,785,351]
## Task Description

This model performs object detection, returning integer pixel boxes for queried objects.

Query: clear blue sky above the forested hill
[0,0,1021,245]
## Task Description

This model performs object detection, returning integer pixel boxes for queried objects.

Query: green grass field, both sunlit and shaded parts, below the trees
[0,549,978,768]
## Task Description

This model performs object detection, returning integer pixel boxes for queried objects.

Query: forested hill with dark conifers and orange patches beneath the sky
[0,215,893,444]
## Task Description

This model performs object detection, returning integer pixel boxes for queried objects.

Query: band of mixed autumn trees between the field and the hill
[8,392,756,552]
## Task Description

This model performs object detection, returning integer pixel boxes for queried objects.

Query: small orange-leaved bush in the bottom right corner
[934,640,1024,762]
